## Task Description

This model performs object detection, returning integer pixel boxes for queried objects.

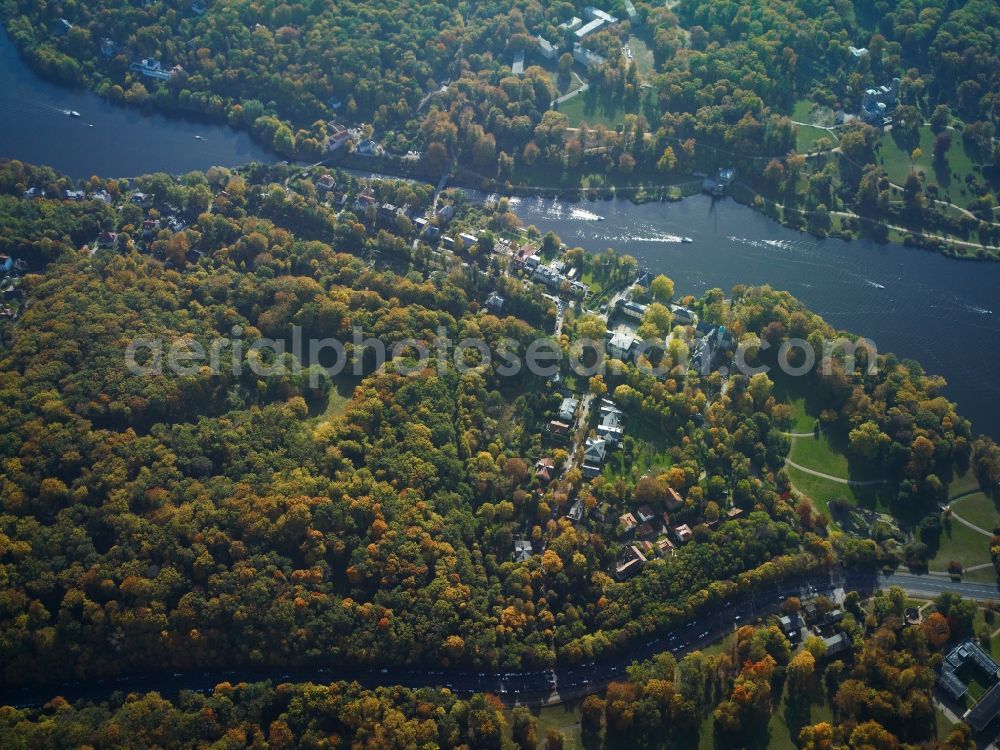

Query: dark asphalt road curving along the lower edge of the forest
[0,569,1000,707]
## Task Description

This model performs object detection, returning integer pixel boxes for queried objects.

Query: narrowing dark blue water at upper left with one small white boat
[0,31,278,177]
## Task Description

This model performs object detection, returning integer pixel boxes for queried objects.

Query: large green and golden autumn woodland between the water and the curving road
[0,157,998,700]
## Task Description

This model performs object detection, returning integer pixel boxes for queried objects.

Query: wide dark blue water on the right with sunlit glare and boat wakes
[512,196,1000,437]
